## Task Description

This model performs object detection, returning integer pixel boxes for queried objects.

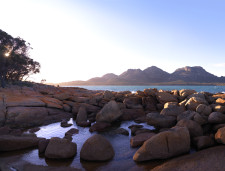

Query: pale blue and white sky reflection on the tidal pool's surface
[22,119,154,170]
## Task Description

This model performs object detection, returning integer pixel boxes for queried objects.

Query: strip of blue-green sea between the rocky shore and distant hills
[75,85,225,93]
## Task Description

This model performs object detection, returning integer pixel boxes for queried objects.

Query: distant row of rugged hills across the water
[59,66,225,86]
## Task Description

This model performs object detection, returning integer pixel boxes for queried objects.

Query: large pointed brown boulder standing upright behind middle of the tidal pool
[96,100,122,122]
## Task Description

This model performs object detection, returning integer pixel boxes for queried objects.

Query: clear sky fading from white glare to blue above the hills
[0,0,225,83]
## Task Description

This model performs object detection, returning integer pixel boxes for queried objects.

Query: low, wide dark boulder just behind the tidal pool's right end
[146,112,177,128]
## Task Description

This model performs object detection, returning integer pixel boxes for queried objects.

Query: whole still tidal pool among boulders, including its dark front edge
[0,119,167,171]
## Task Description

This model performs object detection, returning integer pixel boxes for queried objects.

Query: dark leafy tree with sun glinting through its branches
[0,29,40,87]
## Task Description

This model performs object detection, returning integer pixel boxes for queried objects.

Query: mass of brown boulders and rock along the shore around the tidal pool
[0,86,225,168]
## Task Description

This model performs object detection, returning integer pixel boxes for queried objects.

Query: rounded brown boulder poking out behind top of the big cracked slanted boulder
[177,119,203,137]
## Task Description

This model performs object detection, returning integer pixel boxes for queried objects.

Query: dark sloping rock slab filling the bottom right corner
[151,146,225,171]
